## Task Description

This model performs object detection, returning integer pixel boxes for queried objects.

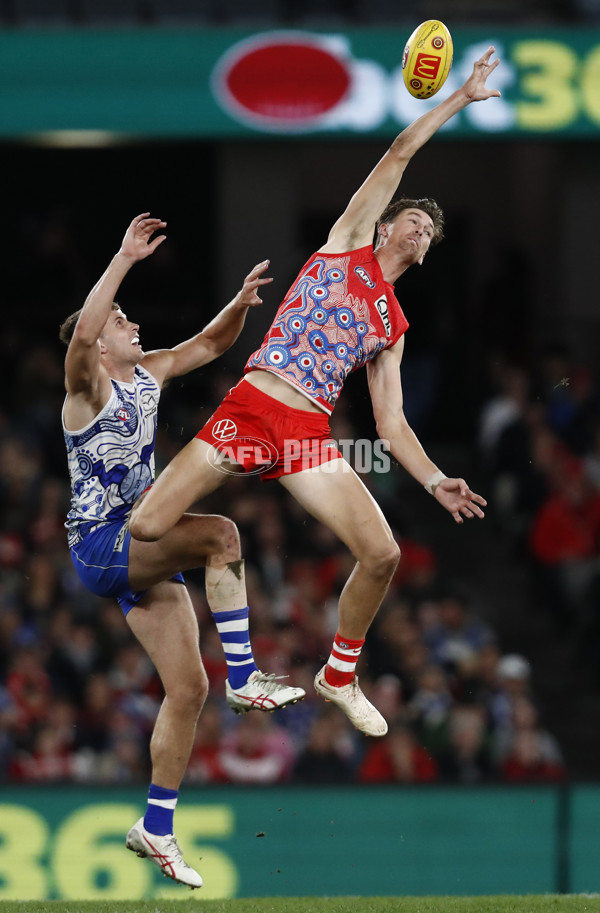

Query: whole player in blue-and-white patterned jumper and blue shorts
[60,212,305,888]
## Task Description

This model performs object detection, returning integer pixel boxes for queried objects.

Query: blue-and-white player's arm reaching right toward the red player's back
[142,260,273,384]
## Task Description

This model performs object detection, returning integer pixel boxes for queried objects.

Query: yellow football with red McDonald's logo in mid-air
[402,19,454,98]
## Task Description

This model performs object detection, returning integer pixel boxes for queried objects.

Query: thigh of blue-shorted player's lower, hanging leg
[127,580,206,693]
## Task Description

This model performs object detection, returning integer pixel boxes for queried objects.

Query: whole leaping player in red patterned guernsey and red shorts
[130,47,500,736]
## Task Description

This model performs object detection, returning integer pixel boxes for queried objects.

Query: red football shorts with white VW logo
[196,380,341,480]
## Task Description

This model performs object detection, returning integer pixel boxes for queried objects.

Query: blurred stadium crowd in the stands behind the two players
[0,306,600,784]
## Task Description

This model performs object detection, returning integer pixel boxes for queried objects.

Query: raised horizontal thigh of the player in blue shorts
[129,514,240,590]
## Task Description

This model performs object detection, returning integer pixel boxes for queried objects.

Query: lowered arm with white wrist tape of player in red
[367,337,487,523]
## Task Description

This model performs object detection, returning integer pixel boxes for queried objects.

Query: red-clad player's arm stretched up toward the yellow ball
[321,47,500,253]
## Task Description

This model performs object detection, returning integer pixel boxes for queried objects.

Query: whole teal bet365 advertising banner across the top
[0,24,600,137]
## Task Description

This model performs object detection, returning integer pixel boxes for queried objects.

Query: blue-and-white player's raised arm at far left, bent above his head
[65,212,167,396]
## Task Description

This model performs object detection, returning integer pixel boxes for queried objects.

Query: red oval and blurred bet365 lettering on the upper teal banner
[211,29,600,135]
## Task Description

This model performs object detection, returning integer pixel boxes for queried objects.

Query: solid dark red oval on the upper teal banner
[224,41,350,123]
